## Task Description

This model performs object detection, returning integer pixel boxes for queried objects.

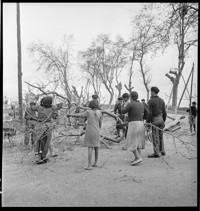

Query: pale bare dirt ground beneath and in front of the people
[2,115,197,207]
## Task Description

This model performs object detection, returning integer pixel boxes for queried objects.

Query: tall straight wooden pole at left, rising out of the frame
[17,3,23,124]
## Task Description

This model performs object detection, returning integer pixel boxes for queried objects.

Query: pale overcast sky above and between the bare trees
[3,3,197,106]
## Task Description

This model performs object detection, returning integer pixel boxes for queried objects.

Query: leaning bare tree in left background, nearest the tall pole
[28,35,73,100]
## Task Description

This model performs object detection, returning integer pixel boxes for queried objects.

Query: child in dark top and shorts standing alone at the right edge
[186,101,197,135]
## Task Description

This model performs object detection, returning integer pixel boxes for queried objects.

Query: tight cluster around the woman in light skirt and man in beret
[114,87,167,165]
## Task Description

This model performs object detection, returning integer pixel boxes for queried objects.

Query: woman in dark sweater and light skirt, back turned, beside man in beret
[122,91,148,165]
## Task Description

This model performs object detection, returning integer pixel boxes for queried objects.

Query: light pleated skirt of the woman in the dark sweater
[124,121,145,151]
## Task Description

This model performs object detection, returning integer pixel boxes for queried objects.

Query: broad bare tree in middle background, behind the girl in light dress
[81,34,127,105]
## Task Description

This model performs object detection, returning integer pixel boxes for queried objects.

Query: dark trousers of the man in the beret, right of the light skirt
[152,116,165,155]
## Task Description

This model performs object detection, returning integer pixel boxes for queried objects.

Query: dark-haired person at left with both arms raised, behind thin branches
[32,96,63,164]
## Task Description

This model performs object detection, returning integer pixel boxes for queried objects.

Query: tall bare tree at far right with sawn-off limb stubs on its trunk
[163,3,198,110]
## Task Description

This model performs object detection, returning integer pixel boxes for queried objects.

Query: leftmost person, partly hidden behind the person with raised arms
[24,102,37,146]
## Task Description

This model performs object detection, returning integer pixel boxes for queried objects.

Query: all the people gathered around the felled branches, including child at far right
[25,87,195,170]
